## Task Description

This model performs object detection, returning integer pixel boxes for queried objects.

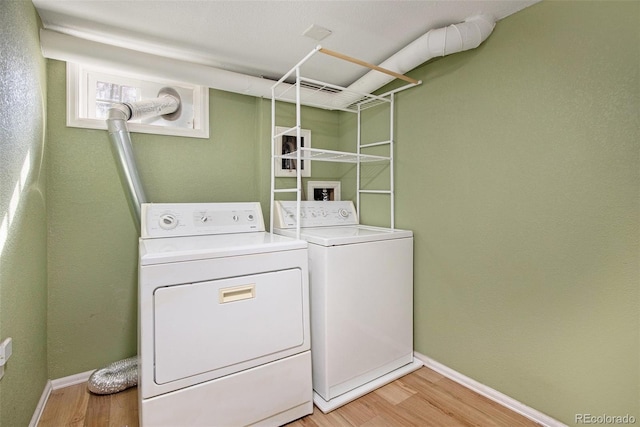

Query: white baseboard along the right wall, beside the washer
[414,352,567,427]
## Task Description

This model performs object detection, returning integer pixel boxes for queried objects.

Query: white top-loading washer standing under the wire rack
[273,201,422,412]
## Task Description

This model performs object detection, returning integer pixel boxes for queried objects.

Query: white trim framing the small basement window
[67,62,209,139]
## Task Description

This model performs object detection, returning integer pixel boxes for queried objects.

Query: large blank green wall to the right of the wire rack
[372,1,640,424]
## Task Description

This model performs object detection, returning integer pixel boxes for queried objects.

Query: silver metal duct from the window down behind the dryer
[107,88,181,231]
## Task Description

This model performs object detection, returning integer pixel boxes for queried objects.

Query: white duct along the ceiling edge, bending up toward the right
[40,15,495,107]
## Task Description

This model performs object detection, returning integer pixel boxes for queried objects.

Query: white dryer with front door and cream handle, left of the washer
[138,203,313,427]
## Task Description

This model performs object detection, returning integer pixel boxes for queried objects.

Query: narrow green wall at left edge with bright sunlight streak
[0,1,48,426]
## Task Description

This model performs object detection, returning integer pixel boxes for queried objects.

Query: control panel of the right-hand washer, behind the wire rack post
[273,200,358,228]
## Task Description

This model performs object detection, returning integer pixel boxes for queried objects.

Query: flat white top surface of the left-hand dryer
[140,232,307,265]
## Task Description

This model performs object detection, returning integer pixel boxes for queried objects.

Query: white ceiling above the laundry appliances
[33,0,539,86]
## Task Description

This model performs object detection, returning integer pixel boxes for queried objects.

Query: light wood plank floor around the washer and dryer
[38,367,537,427]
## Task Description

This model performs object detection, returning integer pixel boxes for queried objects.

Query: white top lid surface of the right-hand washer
[274,225,413,246]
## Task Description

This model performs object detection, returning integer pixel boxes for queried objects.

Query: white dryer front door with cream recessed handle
[154,268,304,384]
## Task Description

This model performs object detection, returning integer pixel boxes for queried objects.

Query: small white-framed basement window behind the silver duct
[67,63,209,138]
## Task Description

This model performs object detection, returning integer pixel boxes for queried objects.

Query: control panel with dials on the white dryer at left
[141,202,265,239]
